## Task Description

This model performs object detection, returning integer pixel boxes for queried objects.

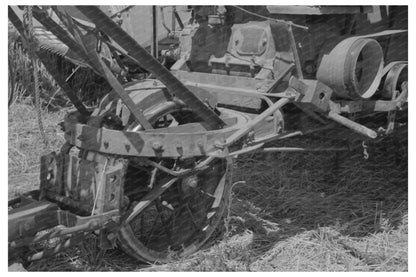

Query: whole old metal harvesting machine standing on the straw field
[8,6,407,263]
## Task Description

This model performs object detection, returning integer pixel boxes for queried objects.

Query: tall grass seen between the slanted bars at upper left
[8,22,110,111]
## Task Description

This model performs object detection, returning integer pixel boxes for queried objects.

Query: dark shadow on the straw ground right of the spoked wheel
[230,126,408,256]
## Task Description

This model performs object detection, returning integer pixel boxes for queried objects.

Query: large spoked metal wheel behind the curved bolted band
[110,96,229,262]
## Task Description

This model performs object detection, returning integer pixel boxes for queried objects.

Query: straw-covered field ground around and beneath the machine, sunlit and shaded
[8,103,408,271]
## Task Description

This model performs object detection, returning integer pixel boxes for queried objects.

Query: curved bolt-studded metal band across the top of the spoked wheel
[65,108,248,157]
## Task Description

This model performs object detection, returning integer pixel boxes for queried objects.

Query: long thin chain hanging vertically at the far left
[23,6,49,148]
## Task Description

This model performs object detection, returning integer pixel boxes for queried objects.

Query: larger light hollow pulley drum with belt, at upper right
[317,37,384,99]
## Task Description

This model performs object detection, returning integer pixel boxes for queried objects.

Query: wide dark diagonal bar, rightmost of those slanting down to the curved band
[76,6,225,129]
